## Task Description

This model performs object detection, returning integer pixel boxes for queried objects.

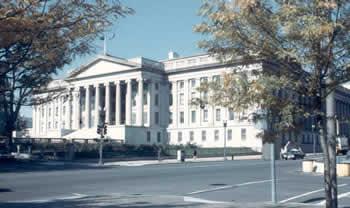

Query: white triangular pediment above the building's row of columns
[69,57,139,79]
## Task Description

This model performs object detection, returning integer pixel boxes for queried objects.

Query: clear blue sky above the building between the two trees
[22,0,203,117]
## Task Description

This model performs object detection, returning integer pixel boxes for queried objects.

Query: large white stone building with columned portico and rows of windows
[31,52,350,151]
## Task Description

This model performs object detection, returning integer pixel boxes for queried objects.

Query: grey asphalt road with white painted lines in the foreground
[0,160,350,208]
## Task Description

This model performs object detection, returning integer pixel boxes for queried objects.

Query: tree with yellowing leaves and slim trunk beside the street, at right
[195,0,350,207]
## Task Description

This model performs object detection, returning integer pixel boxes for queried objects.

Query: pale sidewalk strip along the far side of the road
[100,155,261,166]
